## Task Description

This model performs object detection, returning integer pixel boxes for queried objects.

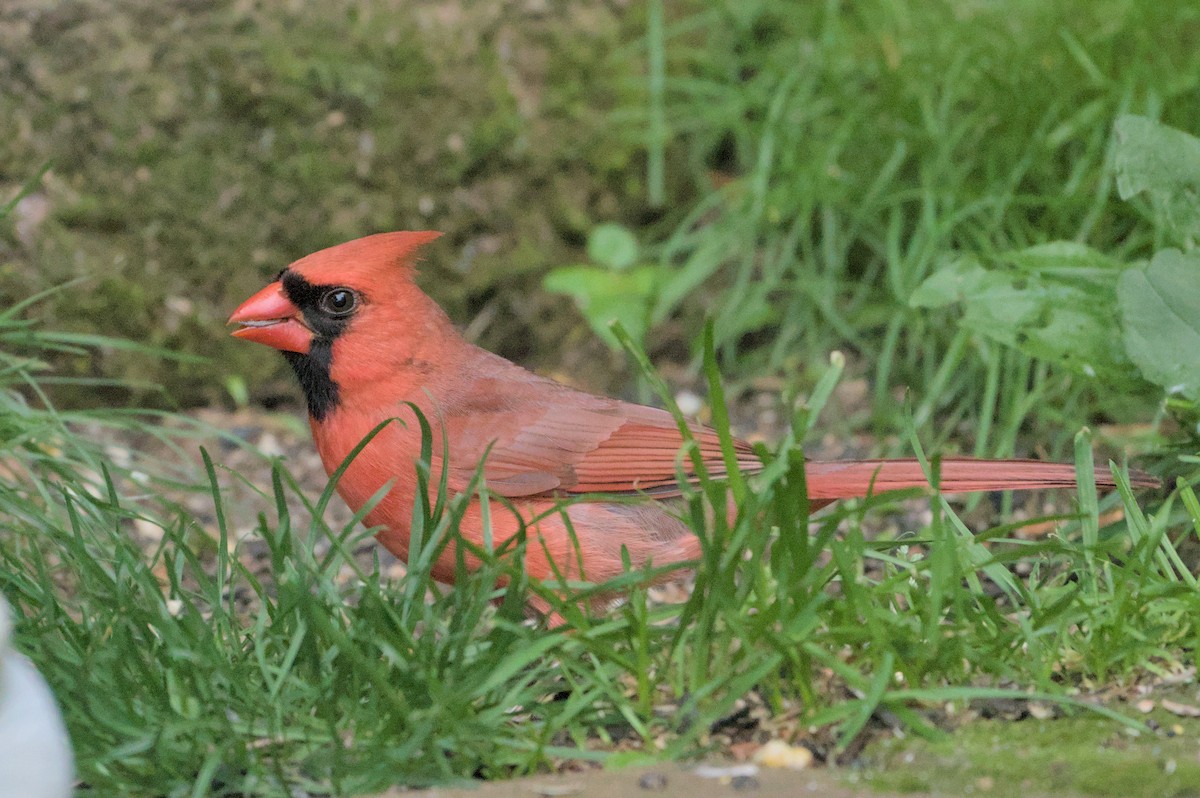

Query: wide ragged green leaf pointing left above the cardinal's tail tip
[910,250,1136,382]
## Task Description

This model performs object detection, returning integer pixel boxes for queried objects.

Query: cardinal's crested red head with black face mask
[229,232,444,420]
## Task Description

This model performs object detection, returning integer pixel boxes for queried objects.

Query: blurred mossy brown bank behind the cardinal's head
[0,0,662,404]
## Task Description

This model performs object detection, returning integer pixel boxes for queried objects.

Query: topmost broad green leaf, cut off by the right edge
[1114,116,1200,246]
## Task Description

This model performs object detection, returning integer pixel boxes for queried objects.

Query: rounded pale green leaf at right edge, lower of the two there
[1117,250,1200,400]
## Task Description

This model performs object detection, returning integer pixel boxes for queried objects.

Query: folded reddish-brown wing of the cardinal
[434,379,762,498]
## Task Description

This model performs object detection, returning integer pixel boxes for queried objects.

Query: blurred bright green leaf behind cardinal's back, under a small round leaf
[542,266,658,349]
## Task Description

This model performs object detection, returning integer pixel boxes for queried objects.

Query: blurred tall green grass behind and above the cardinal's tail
[654,0,1200,454]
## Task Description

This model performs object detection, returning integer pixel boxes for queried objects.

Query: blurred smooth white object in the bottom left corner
[0,596,74,798]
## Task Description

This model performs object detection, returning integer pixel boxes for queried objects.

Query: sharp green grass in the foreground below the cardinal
[0,307,1200,794]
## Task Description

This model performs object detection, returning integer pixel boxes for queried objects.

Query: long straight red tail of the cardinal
[805,457,1158,503]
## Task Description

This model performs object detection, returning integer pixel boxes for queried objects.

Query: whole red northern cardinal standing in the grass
[229,232,1153,600]
